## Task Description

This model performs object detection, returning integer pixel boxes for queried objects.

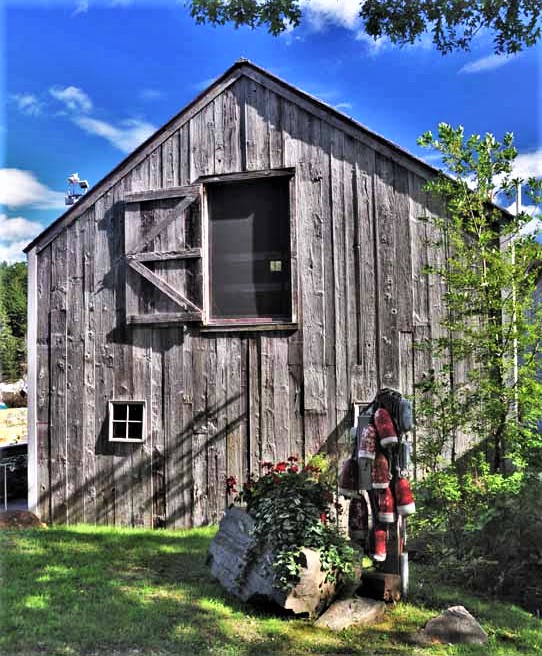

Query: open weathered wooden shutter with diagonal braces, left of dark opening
[124,186,203,324]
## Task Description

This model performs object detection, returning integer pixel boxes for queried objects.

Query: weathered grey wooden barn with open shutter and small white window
[26,60,450,528]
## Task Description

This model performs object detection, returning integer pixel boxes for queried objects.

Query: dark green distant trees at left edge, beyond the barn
[0,262,27,382]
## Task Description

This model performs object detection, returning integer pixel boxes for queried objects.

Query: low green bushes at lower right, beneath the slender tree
[409,468,542,611]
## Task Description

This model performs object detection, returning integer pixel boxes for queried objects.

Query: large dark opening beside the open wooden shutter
[206,175,292,323]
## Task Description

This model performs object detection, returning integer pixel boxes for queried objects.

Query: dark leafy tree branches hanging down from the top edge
[188,0,542,54]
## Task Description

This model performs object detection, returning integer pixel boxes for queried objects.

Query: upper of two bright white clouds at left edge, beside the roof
[0,169,64,210]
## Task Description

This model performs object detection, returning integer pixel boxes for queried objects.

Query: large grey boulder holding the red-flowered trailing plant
[208,507,335,616]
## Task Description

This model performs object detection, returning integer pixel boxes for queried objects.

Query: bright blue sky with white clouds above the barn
[0,0,542,261]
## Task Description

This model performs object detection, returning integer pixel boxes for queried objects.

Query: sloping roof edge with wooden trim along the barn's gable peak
[24,59,446,253]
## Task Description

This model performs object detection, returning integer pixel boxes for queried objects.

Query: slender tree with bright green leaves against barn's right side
[417,123,542,473]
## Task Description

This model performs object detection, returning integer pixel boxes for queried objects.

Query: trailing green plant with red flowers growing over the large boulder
[232,456,357,590]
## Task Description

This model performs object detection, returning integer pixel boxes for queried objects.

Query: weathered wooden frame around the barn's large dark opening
[202,167,298,331]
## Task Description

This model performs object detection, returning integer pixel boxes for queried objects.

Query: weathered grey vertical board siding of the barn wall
[37,74,448,527]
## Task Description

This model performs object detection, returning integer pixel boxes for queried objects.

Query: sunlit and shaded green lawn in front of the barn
[0,526,542,656]
